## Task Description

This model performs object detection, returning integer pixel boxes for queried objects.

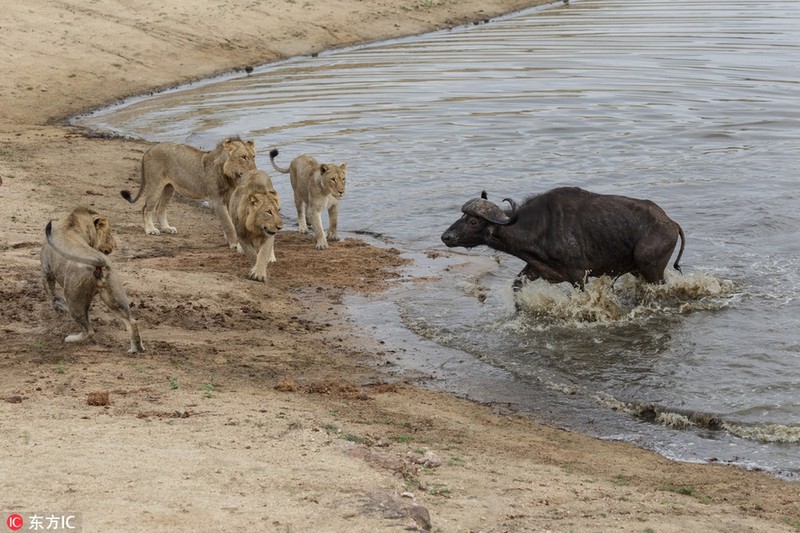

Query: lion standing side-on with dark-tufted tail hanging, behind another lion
[120,137,256,248]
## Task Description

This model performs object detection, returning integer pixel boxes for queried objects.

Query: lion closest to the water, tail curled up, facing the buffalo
[269,149,347,250]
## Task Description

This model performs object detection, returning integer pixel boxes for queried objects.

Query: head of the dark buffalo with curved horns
[442,191,517,248]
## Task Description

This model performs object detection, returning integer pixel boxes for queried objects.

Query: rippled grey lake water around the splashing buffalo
[75,0,800,479]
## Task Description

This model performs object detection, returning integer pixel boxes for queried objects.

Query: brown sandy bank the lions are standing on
[0,0,800,532]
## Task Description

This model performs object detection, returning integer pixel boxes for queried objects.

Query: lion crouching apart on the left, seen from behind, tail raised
[41,207,144,353]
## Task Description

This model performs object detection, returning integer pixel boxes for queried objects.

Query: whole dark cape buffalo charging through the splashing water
[442,187,685,288]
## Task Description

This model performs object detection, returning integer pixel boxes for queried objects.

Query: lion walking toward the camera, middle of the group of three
[228,170,283,281]
